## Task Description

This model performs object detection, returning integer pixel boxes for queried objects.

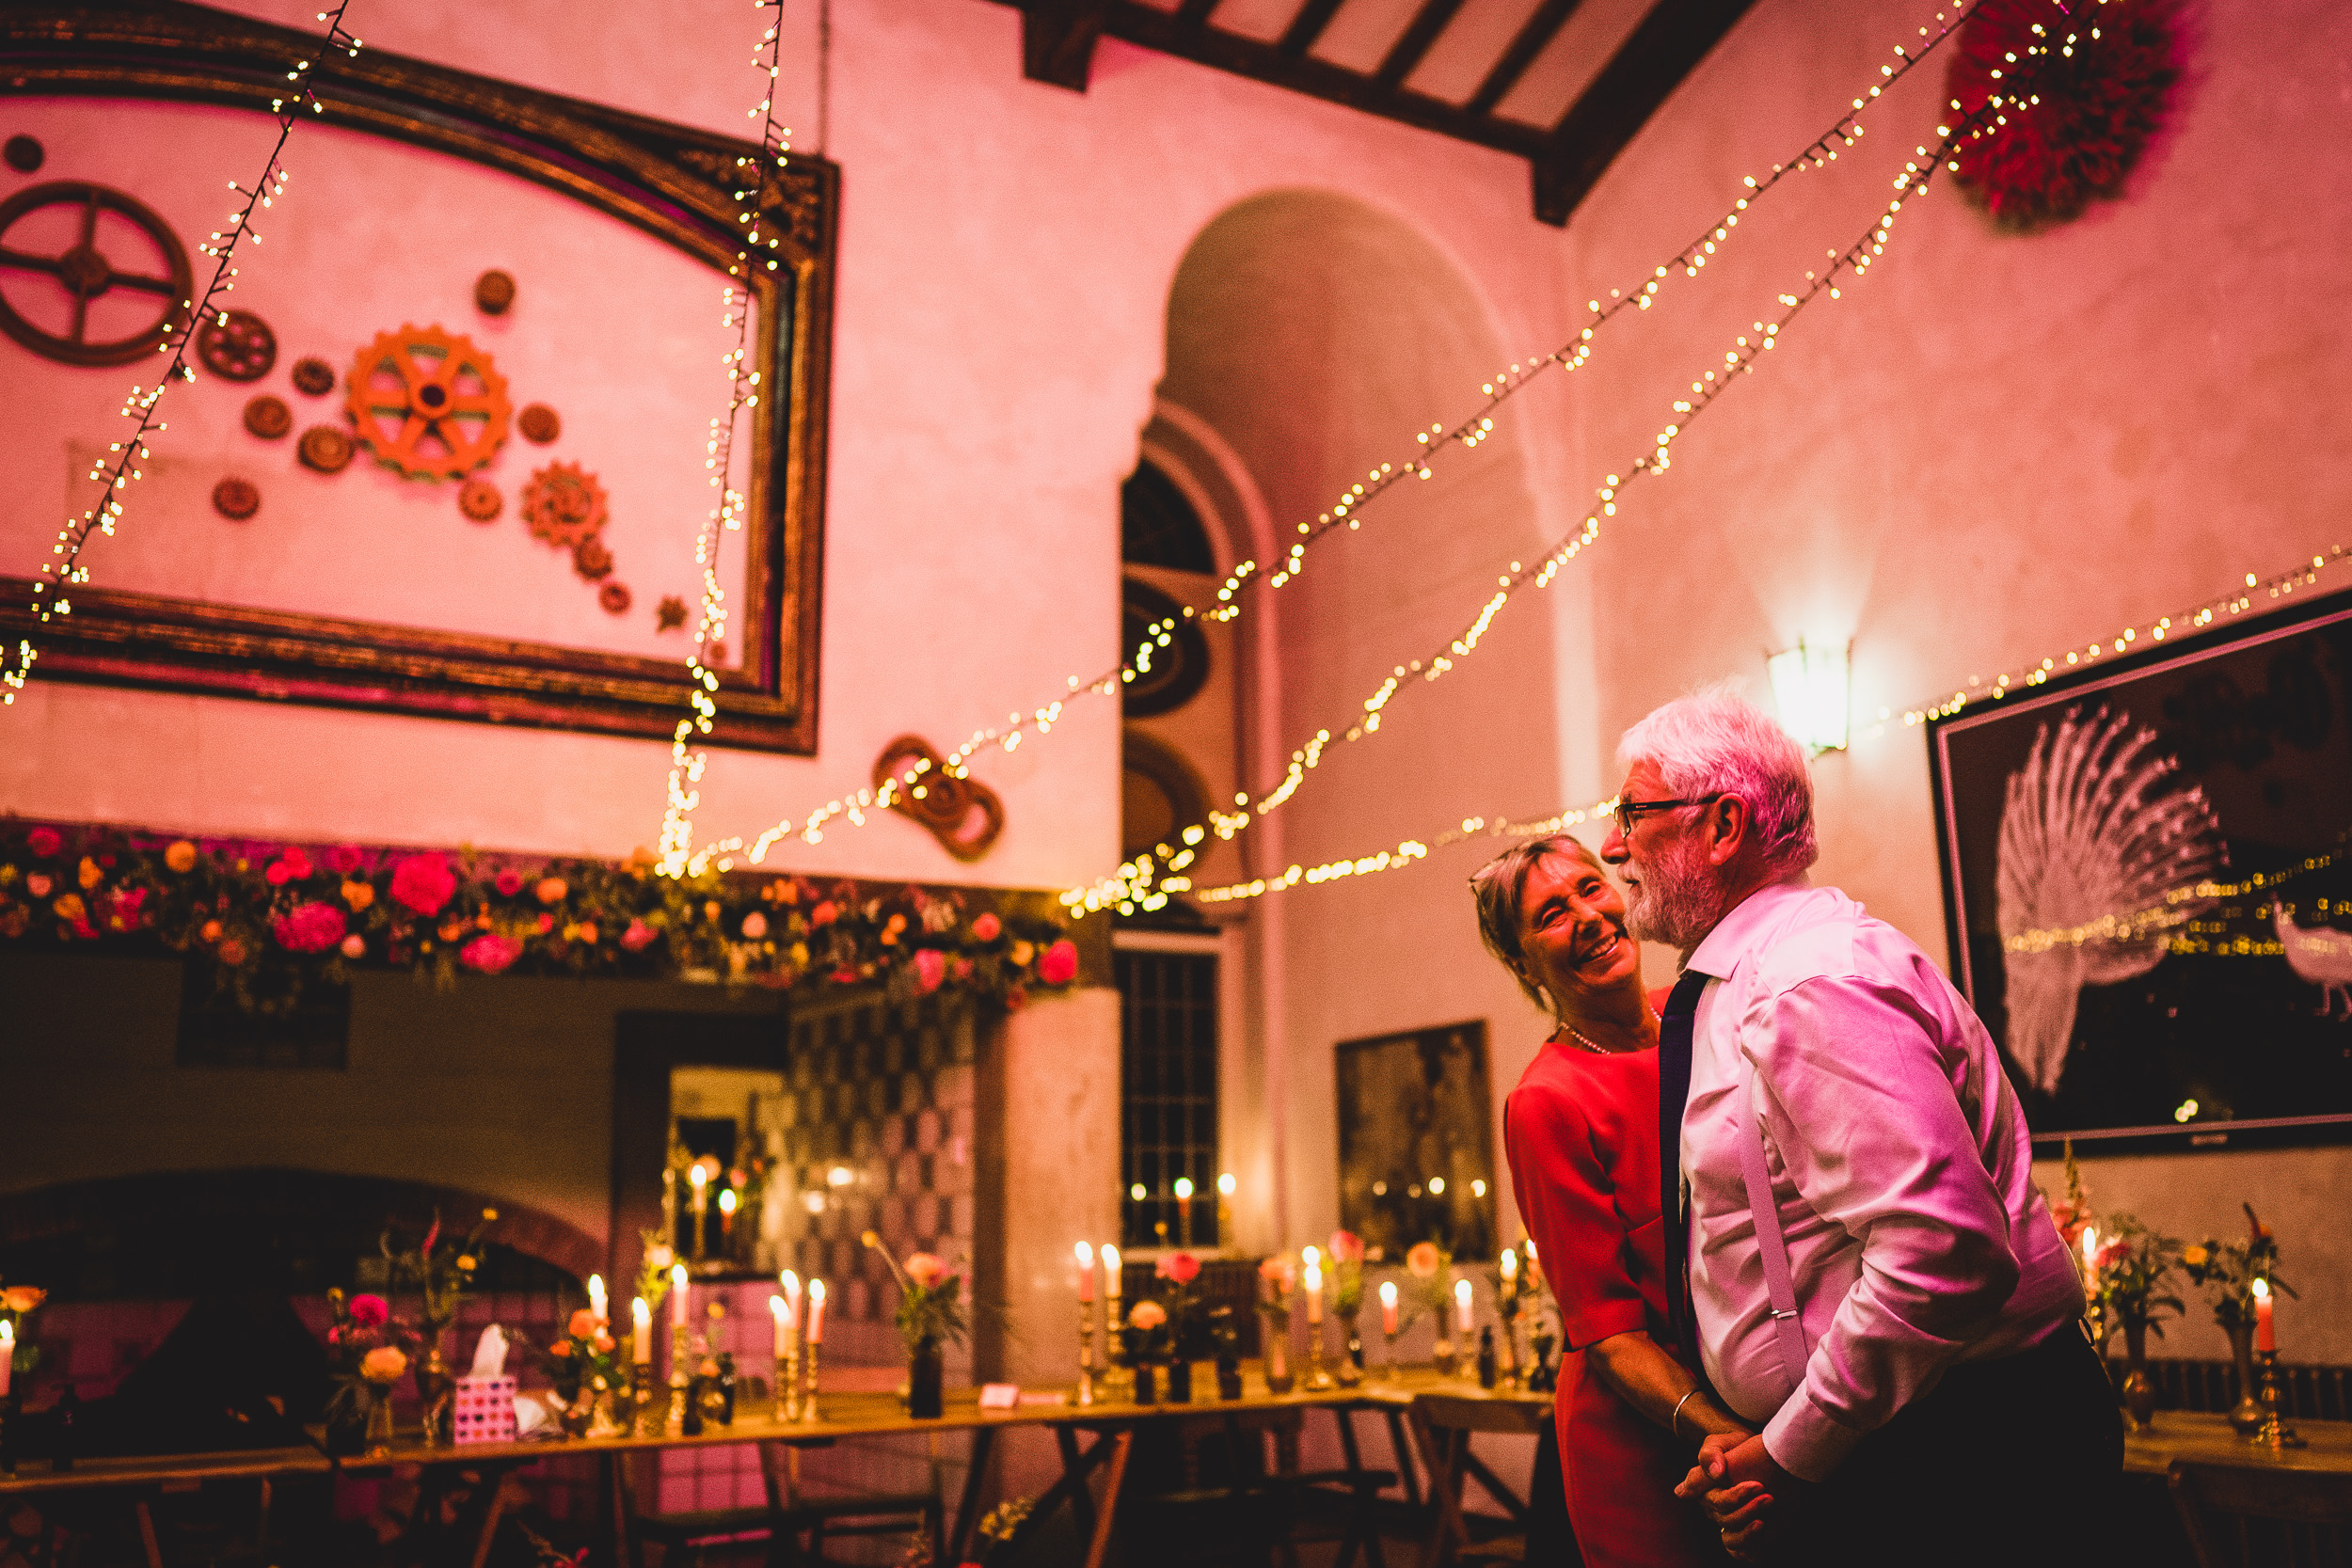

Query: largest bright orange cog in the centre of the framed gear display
[346,325,513,480]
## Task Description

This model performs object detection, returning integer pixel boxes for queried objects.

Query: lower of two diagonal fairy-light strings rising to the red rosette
[1061,96,2007,919]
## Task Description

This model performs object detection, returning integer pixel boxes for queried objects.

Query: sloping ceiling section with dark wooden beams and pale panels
[1002,0,1753,226]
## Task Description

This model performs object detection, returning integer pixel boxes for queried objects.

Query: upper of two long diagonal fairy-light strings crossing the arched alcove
[663,0,1983,875]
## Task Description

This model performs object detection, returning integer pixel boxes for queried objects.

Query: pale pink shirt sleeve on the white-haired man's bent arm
[1740,975,2018,1481]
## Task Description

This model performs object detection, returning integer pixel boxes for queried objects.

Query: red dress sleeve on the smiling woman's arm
[1503,1086,1649,1350]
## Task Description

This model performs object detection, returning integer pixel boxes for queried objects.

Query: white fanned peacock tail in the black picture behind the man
[1997,707,2230,1093]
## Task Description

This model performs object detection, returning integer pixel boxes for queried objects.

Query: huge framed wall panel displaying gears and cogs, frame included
[0,2,840,752]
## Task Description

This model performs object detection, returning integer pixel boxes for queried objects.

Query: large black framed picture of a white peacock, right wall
[1929,594,2352,1152]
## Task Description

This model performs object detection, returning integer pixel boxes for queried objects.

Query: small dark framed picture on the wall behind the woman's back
[1339,1018,1496,1262]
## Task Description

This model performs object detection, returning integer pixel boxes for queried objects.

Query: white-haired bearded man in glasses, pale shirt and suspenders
[1602,691,2122,1568]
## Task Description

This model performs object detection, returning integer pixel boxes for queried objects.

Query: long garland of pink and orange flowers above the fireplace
[0,820,1080,1013]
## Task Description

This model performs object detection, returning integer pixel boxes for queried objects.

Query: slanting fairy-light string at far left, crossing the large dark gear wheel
[0,0,360,707]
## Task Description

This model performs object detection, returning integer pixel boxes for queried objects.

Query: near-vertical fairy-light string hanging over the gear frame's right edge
[657,0,793,877]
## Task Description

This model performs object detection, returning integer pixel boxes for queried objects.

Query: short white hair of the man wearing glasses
[1618,687,1820,877]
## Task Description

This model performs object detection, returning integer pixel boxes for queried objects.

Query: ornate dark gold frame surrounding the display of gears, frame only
[0,0,840,754]
